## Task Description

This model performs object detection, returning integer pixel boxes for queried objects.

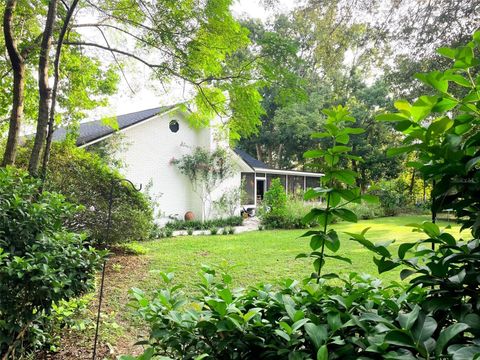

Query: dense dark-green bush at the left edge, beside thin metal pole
[0,168,101,358]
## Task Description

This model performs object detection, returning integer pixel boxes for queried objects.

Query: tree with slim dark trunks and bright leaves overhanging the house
[0,0,262,175]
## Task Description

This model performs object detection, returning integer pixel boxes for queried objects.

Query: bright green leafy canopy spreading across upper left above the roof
[0,0,262,174]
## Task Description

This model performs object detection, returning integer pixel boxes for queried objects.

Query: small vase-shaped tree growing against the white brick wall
[172,147,233,221]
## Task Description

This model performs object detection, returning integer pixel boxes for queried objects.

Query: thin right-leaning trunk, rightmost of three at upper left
[41,0,79,183]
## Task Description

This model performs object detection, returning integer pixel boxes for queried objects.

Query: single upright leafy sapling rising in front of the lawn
[297,105,377,282]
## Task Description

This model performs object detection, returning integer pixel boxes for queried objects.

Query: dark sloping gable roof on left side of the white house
[53,105,176,146]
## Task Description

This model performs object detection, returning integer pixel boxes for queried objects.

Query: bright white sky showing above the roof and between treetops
[90,0,298,118]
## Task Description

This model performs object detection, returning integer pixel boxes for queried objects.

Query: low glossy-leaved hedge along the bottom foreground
[124,267,420,359]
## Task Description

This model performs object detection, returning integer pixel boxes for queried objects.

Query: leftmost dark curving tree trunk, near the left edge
[2,0,25,166]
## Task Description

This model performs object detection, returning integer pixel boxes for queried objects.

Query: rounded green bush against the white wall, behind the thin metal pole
[18,143,153,244]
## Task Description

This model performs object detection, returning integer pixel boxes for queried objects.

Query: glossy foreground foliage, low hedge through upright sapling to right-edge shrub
[126,32,480,360]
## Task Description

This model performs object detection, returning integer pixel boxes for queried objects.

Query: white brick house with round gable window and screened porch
[54,106,322,223]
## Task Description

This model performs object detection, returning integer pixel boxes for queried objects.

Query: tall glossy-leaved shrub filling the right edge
[349,31,480,359]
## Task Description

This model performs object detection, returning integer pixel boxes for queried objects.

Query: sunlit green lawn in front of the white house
[139,216,466,289]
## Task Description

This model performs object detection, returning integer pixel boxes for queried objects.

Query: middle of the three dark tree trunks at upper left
[28,0,57,176]
